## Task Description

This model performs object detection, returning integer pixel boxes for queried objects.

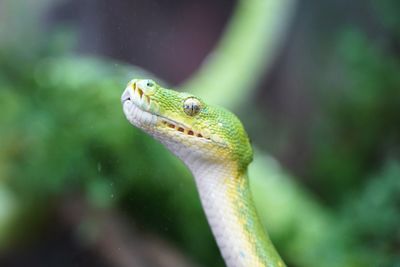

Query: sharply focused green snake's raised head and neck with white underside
[121,79,285,267]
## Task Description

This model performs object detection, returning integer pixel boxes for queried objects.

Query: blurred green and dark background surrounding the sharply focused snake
[0,0,400,267]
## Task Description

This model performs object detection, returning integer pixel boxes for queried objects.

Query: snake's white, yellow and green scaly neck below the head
[187,159,285,267]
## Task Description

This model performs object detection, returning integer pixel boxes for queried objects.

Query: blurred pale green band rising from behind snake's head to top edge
[181,0,296,108]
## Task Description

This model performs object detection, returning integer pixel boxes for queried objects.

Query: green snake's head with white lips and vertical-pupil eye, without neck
[121,79,253,173]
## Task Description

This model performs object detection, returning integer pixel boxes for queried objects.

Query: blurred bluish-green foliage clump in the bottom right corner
[341,161,400,266]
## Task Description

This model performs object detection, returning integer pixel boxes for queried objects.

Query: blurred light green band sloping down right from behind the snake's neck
[249,153,358,267]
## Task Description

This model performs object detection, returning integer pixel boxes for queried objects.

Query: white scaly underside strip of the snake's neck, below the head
[188,161,255,267]
